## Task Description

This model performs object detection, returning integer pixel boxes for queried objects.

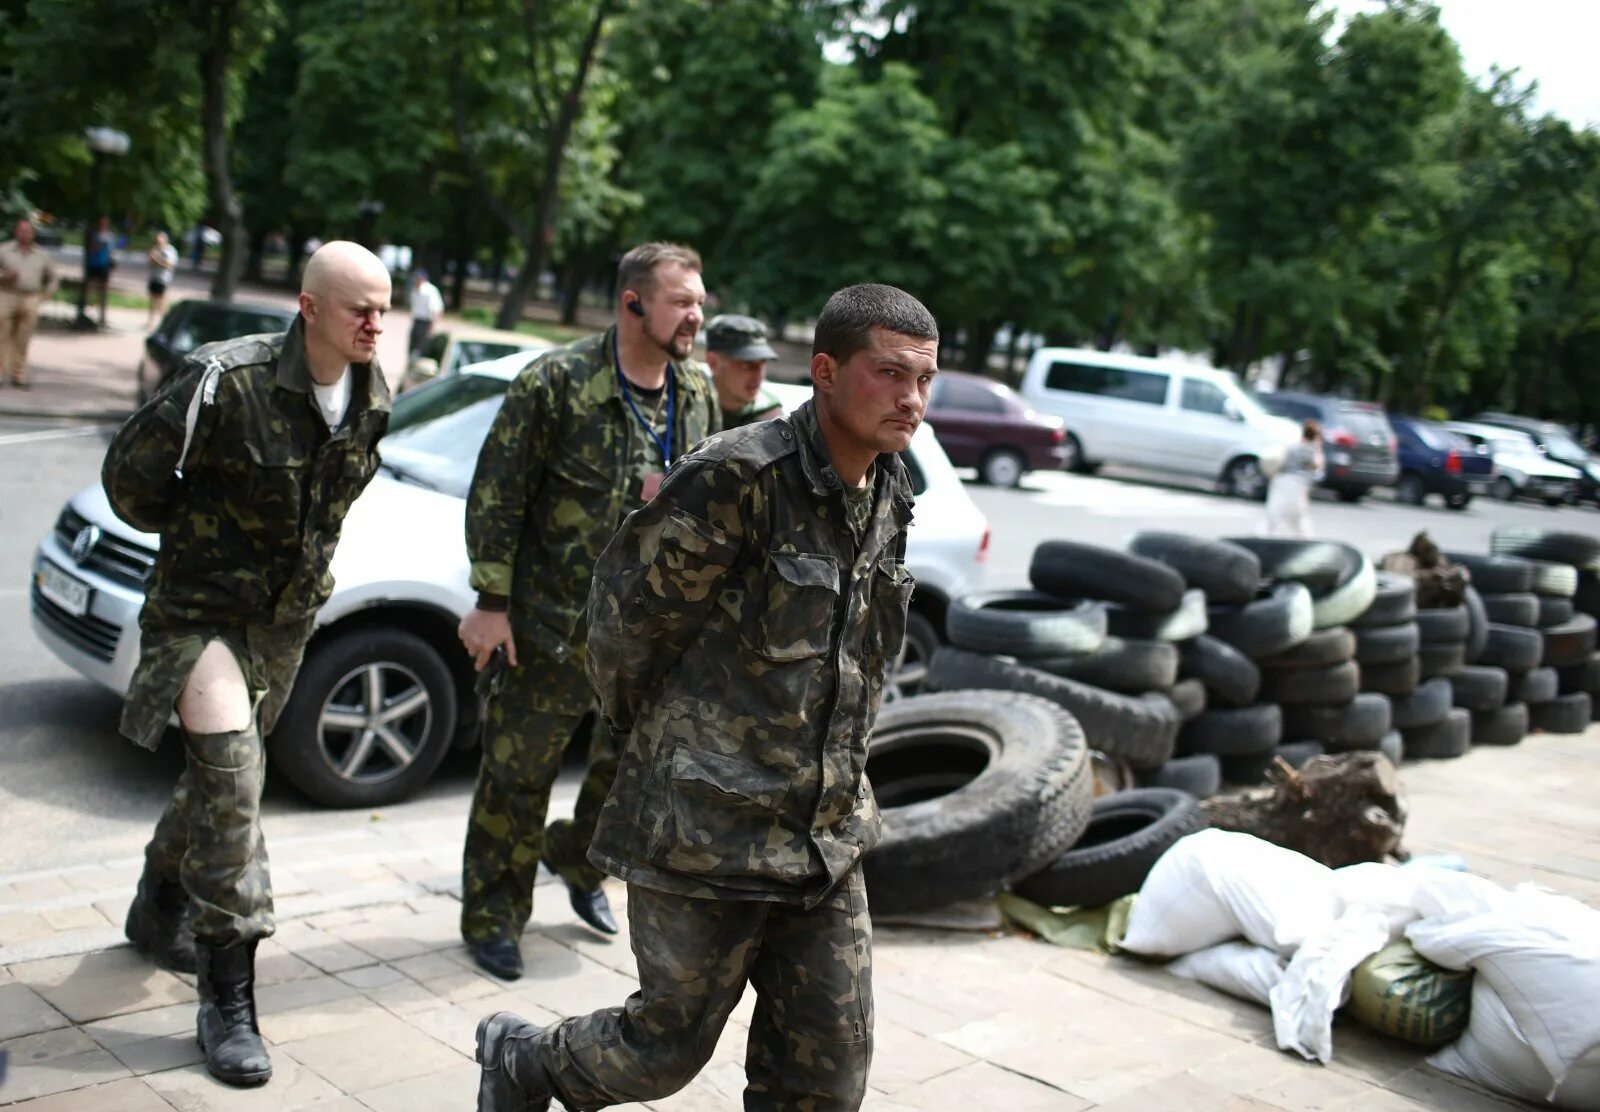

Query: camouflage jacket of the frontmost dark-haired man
[587,403,914,906]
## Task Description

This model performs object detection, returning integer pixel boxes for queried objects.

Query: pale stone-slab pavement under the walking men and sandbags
[0,730,1600,1112]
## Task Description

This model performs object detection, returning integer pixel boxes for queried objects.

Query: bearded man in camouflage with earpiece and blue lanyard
[461,243,717,979]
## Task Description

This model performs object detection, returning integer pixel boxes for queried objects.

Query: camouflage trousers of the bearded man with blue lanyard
[461,645,618,942]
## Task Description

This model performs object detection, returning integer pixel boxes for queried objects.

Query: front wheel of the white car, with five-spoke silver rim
[272,629,456,806]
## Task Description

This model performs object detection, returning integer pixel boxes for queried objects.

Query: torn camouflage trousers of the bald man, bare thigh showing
[139,621,310,947]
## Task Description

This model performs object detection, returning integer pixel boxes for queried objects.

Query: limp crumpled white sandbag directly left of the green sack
[1272,910,1389,1064]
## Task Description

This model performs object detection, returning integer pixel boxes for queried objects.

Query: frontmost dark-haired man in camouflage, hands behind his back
[477,285,939,1112]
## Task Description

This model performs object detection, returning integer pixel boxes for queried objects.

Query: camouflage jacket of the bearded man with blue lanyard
[467,328,718,661]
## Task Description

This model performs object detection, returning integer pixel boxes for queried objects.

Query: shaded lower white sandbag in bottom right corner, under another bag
[1427,976,1600,1112]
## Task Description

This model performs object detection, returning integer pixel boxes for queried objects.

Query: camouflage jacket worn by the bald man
[101,318,389,626]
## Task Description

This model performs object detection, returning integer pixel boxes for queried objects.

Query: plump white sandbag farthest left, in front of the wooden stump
[1122,830,1339,957]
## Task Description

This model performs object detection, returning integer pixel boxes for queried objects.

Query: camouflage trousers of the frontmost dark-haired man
[541,869,872,1112]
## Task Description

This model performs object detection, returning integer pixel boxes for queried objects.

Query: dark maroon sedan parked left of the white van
[926,371,1067,486]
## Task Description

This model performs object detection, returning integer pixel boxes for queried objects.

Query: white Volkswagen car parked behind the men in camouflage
[30,352,989,806]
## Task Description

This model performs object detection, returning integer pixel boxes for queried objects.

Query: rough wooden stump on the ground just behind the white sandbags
[1202,752,1406,869]
